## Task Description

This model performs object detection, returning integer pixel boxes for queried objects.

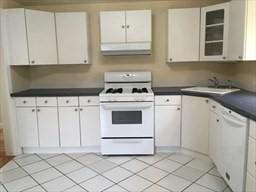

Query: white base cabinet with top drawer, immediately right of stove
[155,96,181,147]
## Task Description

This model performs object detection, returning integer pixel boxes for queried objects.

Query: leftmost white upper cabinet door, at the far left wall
[6,9,29,65]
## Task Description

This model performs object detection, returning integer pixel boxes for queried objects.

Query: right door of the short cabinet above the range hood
[126,10,152,43]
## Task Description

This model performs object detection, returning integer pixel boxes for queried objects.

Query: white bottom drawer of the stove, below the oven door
[101,139,154,155]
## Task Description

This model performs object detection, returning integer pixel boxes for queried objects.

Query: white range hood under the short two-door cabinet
[101,42,152,55]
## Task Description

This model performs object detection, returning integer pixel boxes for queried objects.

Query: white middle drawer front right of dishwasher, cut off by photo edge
[247,137,256,177]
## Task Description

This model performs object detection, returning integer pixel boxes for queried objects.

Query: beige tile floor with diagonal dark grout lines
[0,152,231,192]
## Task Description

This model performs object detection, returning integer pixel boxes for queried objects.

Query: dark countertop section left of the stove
[11,88,103,97]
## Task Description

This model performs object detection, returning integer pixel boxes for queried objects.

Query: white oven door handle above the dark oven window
[100,102,154,110]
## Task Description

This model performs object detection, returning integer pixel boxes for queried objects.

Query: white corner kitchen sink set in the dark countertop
[181,87,240,95]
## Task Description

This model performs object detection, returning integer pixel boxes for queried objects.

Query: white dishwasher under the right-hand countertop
[219,107,248,192]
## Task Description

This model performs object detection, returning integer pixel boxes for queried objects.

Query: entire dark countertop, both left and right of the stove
[11,87,256,121]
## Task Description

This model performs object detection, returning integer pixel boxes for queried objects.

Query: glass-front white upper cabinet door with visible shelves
[200,3,229,61]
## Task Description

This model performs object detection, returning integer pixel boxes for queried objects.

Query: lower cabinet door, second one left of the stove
[59,107,80,147]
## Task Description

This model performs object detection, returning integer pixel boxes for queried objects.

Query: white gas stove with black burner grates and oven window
[100,72,154,155]
